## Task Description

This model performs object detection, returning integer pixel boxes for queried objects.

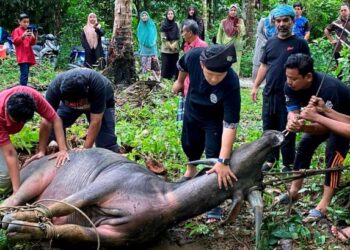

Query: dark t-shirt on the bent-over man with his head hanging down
[46,68,114,114]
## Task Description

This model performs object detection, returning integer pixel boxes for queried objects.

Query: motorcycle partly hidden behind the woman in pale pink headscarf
[68,36,109,70]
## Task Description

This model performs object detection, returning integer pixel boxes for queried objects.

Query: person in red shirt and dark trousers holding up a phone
[12,13,36,86]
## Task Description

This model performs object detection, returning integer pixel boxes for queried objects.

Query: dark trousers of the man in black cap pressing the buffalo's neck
[181,114,223,161]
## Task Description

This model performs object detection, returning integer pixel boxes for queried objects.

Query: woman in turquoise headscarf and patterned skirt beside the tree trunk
[137,11,160,77]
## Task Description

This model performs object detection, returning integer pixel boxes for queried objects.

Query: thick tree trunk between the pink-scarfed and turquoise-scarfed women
[106,0,136,85]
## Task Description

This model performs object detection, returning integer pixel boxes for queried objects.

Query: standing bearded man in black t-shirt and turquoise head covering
[251,5,310,171]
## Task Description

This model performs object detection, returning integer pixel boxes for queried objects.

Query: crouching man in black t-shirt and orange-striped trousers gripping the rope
[280,54,350,221]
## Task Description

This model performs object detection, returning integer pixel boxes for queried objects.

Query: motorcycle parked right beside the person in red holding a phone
[32,34,60,68]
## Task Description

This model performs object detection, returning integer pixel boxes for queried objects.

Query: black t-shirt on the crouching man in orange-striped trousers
[284,72,350,115]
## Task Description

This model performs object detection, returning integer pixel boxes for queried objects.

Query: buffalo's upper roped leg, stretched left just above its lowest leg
[3,178,118,225]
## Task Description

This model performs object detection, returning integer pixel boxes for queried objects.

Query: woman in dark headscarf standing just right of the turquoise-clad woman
[160,9,180,79]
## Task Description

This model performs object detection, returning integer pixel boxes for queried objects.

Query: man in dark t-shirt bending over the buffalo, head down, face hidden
[42,68,118,152]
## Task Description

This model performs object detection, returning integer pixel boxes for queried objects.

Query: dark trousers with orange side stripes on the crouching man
[294,133,349,188]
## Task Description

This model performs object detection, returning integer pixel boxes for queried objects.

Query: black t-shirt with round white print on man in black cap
[178,48,241,124]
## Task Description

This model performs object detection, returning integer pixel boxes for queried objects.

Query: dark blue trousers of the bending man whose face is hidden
[57,103,118,152]
